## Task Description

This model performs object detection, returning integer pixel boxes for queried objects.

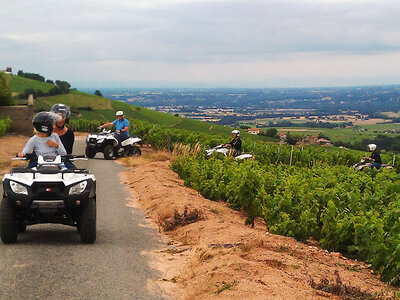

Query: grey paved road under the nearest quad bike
[0,139,167,299]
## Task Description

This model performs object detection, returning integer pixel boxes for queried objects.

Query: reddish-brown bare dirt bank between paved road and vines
[123,150,400,299]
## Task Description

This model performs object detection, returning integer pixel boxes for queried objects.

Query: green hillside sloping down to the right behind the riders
[10,76,275,141]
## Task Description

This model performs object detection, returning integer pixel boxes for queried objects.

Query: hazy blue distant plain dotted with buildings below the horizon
[90,86,400,127]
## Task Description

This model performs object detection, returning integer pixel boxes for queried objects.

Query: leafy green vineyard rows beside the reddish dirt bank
[73,121,400,285]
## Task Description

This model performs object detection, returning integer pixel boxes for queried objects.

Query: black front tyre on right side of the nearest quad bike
[77,198,96,244]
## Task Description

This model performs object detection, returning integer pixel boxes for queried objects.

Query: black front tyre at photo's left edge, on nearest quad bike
[0,198,18,244]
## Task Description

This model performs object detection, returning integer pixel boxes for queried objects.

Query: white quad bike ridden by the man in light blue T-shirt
[85,129,142,159]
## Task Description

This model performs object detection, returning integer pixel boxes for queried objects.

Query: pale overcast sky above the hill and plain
[0,0,400,88]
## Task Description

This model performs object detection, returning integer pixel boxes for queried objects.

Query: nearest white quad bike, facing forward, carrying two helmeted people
[0,154,96,244]
